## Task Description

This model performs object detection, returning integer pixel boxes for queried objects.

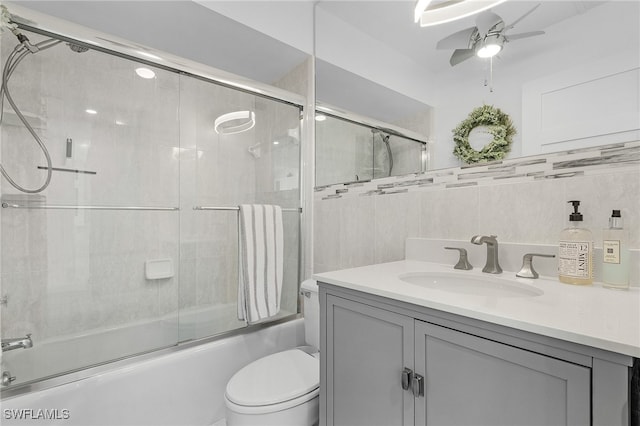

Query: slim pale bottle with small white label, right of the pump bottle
[602,210,629,289]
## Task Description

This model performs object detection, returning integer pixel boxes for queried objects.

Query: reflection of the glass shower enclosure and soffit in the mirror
[316,59,431,186]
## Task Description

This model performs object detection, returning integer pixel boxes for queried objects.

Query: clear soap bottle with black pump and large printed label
[558,201,593,285]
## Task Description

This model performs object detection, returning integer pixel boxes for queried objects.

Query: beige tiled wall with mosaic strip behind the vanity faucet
[314,142,640,272]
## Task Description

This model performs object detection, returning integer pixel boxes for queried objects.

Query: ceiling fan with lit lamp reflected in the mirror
[436,3,544,66]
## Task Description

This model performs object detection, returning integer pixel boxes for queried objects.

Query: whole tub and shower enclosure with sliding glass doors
[0,3,305,425]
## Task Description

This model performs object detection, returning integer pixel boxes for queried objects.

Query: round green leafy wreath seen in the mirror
[452,105,516,164]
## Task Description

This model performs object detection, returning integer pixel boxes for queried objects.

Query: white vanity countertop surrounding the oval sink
[313,260,640,358]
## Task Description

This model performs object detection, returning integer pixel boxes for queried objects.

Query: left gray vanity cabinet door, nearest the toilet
[322,295,414,426]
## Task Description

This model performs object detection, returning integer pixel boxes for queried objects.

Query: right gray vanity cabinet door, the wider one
[415,321,591,426]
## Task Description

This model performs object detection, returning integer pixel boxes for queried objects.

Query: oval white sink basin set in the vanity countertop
[398,272,544,297]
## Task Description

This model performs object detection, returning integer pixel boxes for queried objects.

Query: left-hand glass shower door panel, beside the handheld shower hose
[0,32,180,384]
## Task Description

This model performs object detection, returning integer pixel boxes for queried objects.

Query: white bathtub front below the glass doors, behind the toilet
[0,319,304,426]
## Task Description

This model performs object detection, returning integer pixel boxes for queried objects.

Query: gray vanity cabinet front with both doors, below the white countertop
[320,290,592,426]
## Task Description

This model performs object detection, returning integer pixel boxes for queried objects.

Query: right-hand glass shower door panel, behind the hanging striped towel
[180,77,300,341]
